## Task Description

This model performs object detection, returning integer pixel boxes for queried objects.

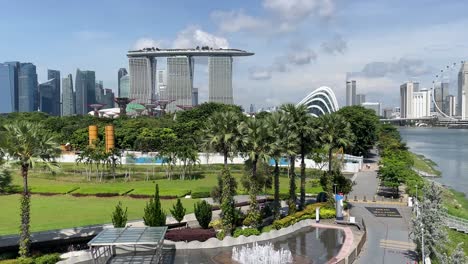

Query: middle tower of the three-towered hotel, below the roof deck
[166,56,194,111]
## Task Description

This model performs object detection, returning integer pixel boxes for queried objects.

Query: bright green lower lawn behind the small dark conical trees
[0,194,197,235]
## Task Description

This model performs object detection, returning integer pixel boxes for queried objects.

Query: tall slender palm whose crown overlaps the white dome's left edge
[281,104,315,210]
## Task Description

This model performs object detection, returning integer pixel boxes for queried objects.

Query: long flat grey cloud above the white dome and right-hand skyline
[348,58,433,78]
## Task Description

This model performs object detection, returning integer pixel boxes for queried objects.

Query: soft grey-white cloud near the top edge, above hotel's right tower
[211,9,269,32]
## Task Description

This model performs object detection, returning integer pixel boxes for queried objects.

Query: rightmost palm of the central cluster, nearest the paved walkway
[319,113,354,175]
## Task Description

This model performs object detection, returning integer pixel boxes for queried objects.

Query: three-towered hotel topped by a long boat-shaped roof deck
[127,47,254,111]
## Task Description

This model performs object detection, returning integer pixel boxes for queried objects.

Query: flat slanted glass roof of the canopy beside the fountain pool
[88,226,167,247]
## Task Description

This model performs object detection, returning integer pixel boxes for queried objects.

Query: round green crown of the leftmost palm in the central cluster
[202,111,240,169]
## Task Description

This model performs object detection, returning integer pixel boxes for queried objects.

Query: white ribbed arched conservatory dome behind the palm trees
[298,86,339,117]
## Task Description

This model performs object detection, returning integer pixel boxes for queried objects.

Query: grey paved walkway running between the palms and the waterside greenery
[350,151,415,264]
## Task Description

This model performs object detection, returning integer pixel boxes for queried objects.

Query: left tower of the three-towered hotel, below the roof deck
[128,57,157,104]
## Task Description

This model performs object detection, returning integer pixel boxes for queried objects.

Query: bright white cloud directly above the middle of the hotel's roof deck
[172,26,229,48]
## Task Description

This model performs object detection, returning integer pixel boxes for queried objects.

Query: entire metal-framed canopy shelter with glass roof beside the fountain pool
[88,226,167,263]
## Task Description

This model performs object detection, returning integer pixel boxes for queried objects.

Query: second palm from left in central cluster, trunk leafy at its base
[240,118,271,227]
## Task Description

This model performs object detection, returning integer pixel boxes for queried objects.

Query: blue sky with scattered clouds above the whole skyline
[0,0,468,107]
